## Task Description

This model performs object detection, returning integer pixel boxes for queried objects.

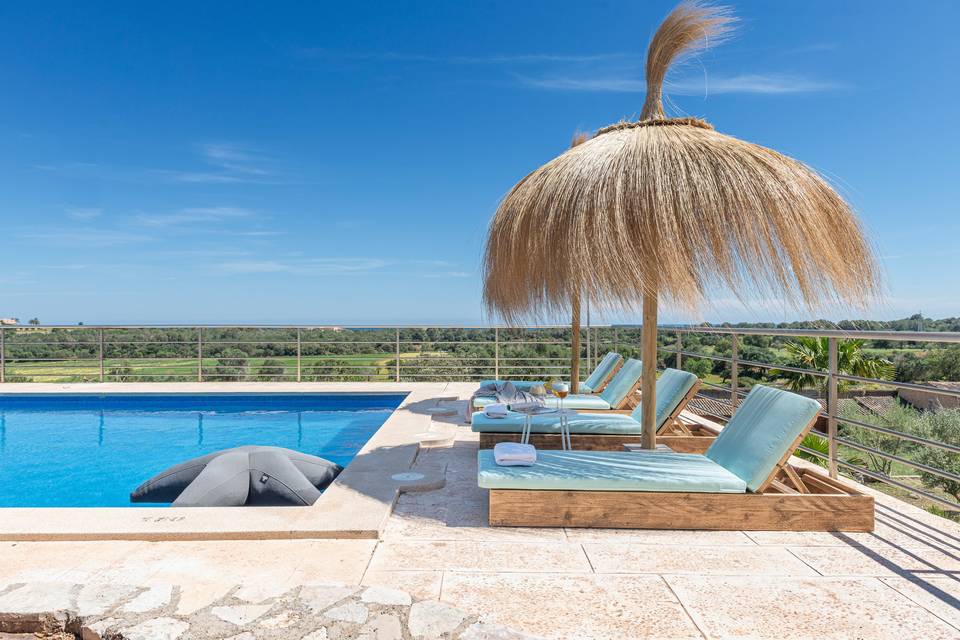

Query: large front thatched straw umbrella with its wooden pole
[484,2,879,448]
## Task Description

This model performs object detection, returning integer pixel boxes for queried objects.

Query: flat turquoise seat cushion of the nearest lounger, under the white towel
[477,449,746,493]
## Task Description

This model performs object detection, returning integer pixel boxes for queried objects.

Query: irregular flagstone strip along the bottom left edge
[0,583,532,640]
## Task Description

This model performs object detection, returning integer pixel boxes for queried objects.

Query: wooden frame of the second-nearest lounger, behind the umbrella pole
[480,380,718,453]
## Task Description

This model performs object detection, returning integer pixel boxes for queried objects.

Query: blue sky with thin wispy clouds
[0,0,960,324]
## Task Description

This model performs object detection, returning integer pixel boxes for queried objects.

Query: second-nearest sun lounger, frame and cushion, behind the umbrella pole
[472,369,717,453]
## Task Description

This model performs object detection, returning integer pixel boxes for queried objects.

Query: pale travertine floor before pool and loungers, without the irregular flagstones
[0,385,960,640]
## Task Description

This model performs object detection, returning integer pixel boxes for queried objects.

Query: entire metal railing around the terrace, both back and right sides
[0,325,960,510]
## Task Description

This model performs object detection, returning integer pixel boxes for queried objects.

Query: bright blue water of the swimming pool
[0,394,404,508]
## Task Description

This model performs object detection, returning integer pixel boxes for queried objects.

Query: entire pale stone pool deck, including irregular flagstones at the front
[0,383,960,640]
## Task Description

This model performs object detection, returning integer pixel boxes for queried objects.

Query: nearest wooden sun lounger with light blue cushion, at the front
[477,385,874,531]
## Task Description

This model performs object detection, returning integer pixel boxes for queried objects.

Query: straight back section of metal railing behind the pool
[0,325,596,382]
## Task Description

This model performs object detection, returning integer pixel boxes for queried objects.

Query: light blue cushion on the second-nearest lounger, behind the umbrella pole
[471,369,697,436]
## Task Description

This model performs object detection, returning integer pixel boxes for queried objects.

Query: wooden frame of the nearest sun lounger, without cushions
[489,418,874,531]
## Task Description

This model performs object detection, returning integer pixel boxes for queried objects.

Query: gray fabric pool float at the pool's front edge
[130,446,343,507]
